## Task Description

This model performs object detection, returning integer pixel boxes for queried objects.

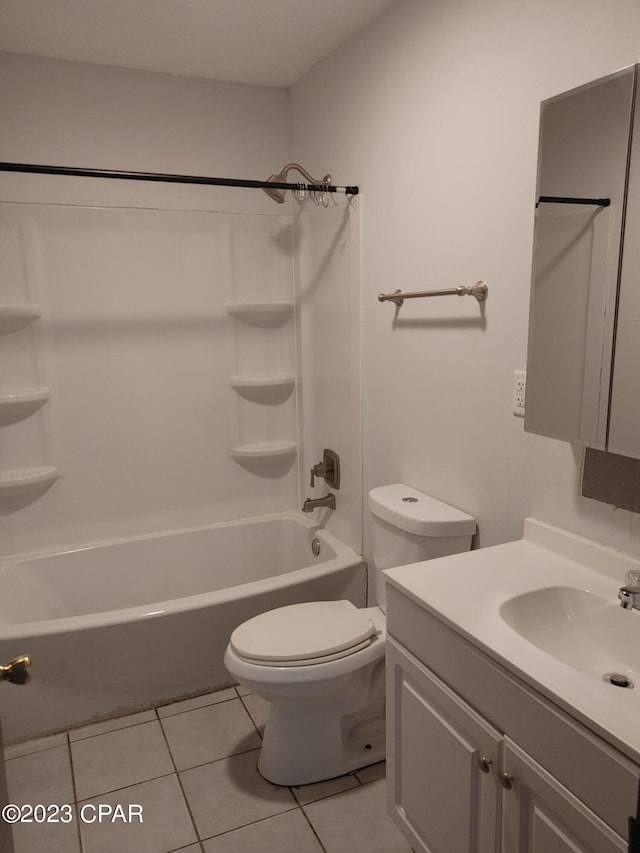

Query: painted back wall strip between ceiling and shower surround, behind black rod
[0,53,290,213]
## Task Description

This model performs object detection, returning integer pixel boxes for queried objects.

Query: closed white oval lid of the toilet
[231,601,378,665]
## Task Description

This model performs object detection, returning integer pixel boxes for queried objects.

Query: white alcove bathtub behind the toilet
[0,512,366,743]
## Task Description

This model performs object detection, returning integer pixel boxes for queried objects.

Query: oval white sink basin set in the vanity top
[500,586,640,687]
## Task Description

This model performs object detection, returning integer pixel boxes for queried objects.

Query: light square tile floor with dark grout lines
[5,688,410,853]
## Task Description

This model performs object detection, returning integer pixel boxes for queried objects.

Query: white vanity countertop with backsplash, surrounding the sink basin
[385,519,640,762]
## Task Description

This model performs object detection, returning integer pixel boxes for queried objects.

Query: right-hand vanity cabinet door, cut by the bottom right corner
[501,737,627,853]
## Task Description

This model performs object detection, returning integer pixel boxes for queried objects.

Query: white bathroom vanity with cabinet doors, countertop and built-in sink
[386,519,640,853]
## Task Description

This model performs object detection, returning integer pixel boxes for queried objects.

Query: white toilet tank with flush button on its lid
[369,483,476,612]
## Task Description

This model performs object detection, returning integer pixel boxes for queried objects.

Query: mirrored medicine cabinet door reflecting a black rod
[525,67,640,456]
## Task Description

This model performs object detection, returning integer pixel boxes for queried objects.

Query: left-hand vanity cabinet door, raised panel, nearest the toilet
[386,639,500,853]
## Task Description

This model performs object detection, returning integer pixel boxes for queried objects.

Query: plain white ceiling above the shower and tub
[0,0,394,87]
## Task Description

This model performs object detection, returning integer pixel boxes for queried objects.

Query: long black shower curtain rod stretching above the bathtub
[0,162,360,195]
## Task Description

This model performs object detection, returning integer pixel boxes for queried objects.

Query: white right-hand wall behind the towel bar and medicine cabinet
[291,0,640,551]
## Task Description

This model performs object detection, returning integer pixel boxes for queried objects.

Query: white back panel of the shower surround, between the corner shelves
[0,204,297,550]
